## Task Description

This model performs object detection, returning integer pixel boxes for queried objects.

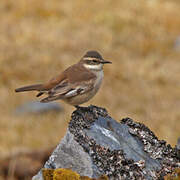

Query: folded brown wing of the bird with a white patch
[41,65,96,102]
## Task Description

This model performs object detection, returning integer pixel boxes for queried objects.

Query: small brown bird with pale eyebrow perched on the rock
[15,50,112,108]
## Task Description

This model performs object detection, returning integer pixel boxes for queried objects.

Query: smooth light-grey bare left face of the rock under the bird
[33,131,93,180]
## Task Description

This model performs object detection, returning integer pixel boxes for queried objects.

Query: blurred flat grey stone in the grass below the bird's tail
[15,101,63,114]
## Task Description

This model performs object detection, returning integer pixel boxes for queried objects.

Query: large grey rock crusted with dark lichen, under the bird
[33,106,180,180]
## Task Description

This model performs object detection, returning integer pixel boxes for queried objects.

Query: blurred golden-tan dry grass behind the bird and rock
[0,0,180,178]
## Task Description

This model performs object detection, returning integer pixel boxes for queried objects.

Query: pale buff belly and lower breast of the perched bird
[63,72,103,106]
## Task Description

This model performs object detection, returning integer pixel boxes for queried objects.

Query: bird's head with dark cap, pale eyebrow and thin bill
[81,51,112,71]
